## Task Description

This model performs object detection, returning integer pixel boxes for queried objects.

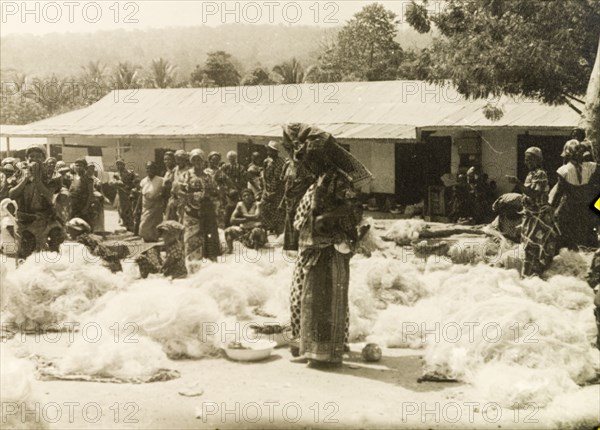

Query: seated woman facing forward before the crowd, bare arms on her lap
[225,189,267,254]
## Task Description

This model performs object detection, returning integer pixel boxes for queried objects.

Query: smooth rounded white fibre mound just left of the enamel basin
[81,279,223,358]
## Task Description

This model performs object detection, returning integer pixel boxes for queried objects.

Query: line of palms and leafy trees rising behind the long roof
[0,0,600,144]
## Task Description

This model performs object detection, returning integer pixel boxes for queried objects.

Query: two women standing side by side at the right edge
[508,135,600,276]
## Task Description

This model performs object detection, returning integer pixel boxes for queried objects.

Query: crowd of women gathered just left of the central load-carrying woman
[111,141,285,261]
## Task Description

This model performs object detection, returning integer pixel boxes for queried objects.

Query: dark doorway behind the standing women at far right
[517,134,569,186]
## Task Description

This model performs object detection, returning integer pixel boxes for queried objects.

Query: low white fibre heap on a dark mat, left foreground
[54,326,167,381]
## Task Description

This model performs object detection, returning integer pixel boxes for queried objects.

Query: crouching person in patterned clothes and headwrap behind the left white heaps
[135,220,187,279]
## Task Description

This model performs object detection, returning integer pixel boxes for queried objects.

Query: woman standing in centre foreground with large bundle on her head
[292,122,371,366]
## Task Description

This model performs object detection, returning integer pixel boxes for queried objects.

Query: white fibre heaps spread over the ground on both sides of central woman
[5,228,599,416]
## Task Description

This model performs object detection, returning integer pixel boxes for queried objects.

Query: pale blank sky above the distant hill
[0,0,442,36]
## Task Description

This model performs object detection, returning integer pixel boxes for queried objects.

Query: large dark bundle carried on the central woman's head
[283,123,373,187]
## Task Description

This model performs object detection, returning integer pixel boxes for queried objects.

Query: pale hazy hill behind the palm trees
[0,24,431,78]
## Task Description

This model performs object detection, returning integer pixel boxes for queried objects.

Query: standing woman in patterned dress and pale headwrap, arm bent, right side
[507,146,558,276]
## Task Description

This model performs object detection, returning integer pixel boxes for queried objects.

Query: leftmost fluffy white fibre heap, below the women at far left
[5,244,125,329]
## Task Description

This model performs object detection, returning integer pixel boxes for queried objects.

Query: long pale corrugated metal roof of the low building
[0,81,579,141]
